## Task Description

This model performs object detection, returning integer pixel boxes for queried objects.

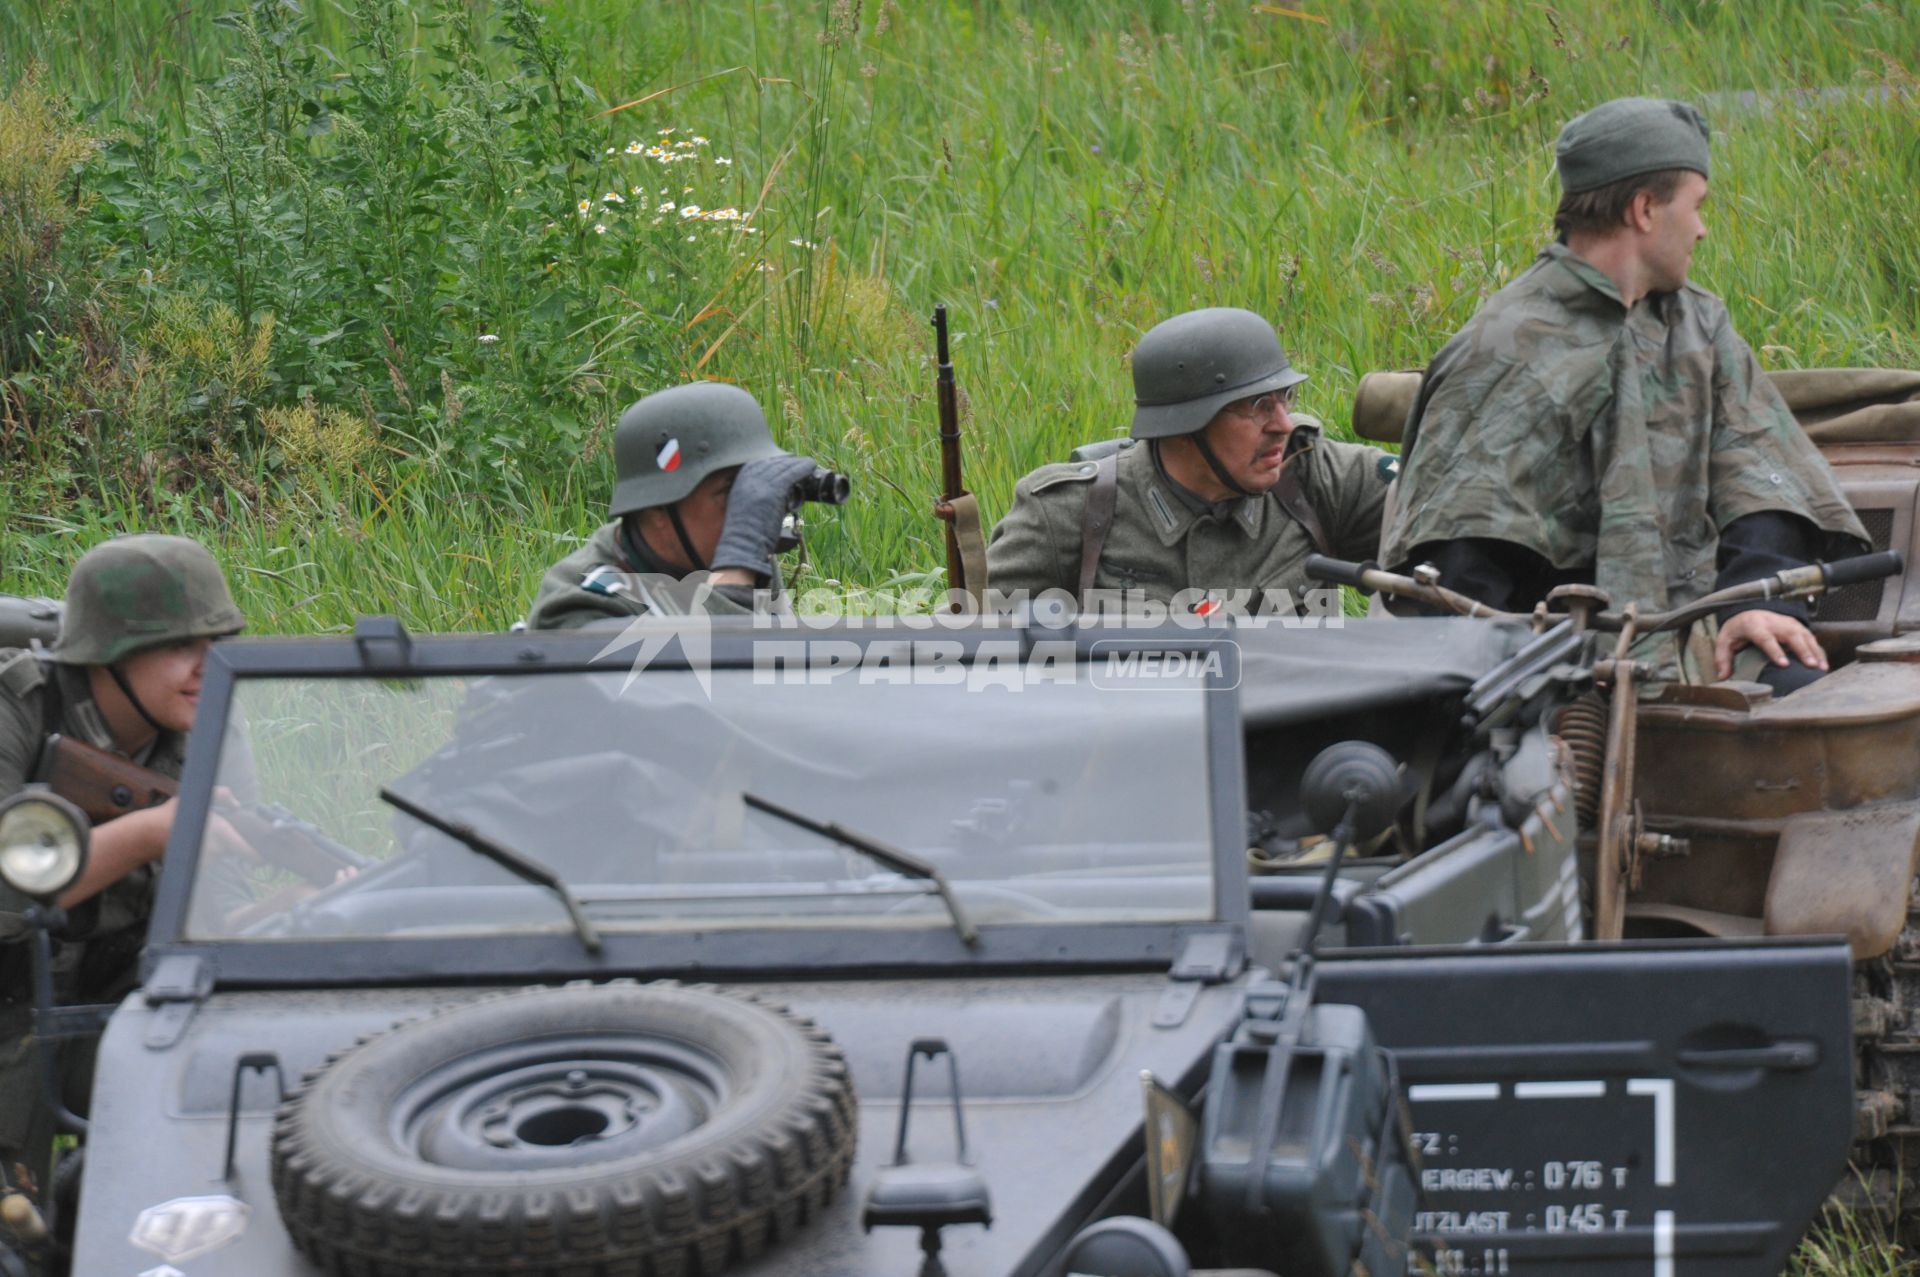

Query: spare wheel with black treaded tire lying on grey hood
[273,981,856,1277]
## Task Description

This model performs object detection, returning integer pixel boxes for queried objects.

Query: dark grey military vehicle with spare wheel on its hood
[0,570,1881,1277]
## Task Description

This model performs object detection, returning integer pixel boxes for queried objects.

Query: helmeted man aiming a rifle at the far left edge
[0,536,246,1205]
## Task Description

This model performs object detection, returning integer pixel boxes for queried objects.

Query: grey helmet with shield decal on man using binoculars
[611,382,783,518]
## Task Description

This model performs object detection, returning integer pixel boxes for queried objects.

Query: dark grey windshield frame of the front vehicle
[153,616,1250,987]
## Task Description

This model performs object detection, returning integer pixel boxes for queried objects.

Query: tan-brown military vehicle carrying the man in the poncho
[1354,369,1920,1239]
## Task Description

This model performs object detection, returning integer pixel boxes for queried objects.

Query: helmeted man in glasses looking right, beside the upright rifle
[987,309,1392,605]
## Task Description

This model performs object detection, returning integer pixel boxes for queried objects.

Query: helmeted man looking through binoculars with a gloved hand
[526,382,848,630]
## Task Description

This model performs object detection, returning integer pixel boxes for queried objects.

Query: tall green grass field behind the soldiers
[0,0,1920,630]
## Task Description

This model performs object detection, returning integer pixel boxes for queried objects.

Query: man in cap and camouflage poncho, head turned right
[1380,98,1864,693]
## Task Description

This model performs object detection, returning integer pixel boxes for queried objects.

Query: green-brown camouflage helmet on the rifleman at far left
[48,534,246,664]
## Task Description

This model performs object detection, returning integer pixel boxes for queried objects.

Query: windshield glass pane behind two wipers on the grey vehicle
[186,668,1213,943]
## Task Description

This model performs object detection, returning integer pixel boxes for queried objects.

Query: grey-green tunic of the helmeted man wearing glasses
[987,428,1392,603]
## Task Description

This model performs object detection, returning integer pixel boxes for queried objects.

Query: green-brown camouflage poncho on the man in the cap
[1380,244,1866,609]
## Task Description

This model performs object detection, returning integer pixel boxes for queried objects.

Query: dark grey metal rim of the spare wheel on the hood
[392,1033,733,1171]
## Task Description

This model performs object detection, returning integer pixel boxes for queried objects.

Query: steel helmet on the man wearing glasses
[1133,307,1308,440]
